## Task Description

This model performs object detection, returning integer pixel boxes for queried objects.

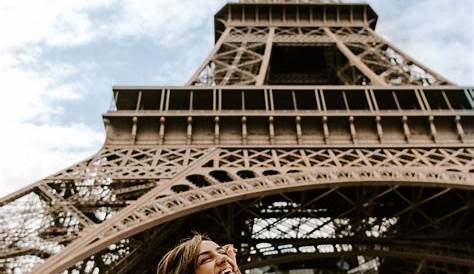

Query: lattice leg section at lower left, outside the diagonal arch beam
[0,147,208,272]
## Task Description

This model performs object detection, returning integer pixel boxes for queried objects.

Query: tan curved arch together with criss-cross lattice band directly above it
[15,149,474,273]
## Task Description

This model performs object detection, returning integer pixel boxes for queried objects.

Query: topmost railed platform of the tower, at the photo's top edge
[215,0,377,40]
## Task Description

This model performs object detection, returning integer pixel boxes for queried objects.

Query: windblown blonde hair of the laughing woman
[156,234,210,274]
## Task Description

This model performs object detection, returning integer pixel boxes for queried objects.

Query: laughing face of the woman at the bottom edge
[195,240,238,274]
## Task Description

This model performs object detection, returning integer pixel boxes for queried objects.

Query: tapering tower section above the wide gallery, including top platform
[187,0,451,86]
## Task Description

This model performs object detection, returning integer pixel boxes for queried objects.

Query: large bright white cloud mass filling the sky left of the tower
[0,1,109,197]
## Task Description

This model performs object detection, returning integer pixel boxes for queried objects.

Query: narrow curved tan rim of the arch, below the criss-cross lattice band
[30,164,473,272]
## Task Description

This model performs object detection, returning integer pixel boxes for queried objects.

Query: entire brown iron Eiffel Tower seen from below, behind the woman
[0,0,474,274]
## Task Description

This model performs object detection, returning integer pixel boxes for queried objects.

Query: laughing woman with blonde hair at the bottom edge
[157,234,241,274]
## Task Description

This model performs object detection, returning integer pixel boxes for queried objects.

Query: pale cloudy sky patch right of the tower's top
[369,0,474,85]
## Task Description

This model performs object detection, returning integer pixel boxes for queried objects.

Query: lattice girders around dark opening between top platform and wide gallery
[187,23,452,86]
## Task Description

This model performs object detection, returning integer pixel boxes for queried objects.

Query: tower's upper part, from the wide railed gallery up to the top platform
[105,1,474,148]
